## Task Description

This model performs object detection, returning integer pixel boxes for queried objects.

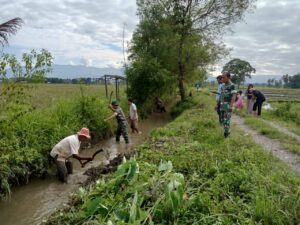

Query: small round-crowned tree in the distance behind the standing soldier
[223,59,255,88]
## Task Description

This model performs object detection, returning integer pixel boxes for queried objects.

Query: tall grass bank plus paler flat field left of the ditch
[0,84,128,198]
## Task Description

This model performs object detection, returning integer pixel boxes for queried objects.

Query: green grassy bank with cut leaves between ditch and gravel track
[47,92,300,224]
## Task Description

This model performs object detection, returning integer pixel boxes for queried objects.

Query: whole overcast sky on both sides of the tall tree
[0,0,300,75]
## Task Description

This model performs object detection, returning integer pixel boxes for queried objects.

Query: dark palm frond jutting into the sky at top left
[0,17,23,46]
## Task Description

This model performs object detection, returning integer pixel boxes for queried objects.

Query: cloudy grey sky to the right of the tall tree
[219,0,300,75]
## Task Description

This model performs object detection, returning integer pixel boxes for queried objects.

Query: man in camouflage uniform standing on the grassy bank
[220,72,237,138]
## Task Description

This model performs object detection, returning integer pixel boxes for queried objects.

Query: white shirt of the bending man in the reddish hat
[50,134,80,161]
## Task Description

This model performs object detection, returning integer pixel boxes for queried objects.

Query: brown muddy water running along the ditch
[0,114,169,225]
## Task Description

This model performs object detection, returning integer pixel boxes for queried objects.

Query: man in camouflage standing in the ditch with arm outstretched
[104,101,129,144]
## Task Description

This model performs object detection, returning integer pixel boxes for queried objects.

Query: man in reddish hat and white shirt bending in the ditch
[50,127,92,182]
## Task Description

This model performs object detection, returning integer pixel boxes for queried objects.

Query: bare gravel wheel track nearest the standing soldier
[232,115,300,173]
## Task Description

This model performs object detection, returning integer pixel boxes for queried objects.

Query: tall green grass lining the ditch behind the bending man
[0,91,112,197]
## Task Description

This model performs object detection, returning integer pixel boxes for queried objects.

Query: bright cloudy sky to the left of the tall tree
[0,0,138,67]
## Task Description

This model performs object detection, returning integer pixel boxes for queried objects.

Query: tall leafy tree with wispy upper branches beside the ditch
[130,0,253,103]
